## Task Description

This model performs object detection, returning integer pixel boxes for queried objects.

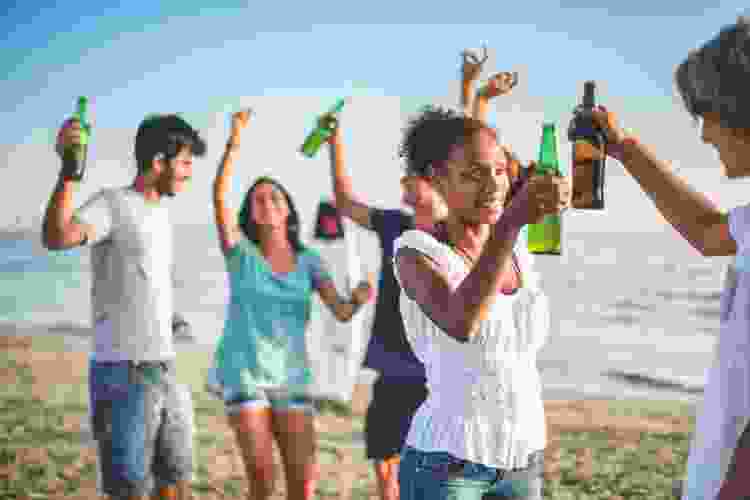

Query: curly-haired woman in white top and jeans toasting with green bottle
[394,108,570,500]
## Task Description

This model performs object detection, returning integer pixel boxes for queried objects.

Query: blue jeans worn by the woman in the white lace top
[398,446,544,500]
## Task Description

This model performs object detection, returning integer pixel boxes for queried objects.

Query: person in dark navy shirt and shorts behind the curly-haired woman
[329,123,443,500]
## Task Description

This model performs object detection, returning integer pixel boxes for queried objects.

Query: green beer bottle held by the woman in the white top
[527,122,562,255]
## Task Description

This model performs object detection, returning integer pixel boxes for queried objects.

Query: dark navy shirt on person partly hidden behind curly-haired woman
[363,209,425,382]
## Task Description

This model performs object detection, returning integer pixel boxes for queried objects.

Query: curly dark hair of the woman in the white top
[398,106,497,177]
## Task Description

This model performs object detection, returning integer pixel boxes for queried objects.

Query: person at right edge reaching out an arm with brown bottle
[593,17,750,500]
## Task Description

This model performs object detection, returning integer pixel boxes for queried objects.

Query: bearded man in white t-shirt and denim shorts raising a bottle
[42,115,206,500]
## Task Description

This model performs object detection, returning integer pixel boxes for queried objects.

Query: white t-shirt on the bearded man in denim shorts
[76,187,175,361]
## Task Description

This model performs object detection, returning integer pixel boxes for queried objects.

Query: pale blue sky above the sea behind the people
[0,0,750,236]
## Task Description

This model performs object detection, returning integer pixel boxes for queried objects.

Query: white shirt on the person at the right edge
[682,201,750,500]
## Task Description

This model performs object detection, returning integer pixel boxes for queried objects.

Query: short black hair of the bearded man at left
[135,114,206,174]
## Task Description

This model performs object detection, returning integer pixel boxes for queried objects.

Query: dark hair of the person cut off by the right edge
[675,17,750,130]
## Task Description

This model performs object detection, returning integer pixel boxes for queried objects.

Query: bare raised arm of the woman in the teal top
[214,110,250,253]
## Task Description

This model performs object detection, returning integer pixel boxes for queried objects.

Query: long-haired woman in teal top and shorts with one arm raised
[214,111,373,500]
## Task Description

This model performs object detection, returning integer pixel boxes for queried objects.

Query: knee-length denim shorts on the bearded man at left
[89,360,193,498]
